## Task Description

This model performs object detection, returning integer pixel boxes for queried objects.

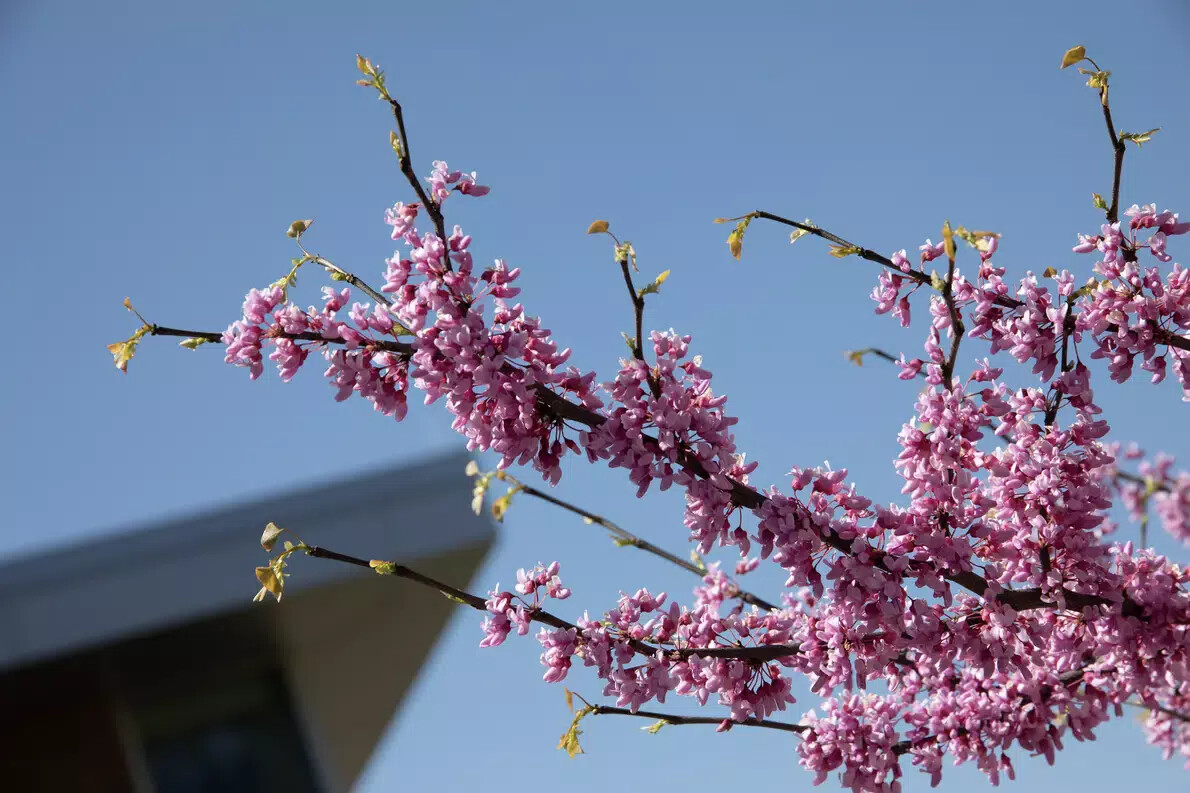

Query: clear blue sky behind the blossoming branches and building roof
[0,0,1190,792]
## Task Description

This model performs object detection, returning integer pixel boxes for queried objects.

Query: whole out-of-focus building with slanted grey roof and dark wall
[0,456,493,793]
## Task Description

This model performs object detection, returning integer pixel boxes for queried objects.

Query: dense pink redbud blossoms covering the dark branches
[214,152,1190,792]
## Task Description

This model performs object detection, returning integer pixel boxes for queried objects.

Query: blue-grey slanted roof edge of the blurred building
[0,454,494,670]
